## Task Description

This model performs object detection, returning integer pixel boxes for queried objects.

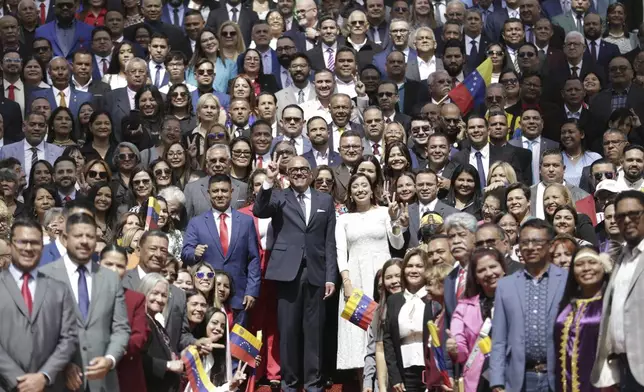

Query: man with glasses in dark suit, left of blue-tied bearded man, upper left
[105,58,148,142]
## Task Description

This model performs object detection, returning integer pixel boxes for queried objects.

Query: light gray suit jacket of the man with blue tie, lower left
[36,259,130,392]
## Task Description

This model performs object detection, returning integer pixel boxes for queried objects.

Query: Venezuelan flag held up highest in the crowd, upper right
[447,59,492,115]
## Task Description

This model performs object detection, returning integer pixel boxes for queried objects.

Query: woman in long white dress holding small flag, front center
[335,173,409,369]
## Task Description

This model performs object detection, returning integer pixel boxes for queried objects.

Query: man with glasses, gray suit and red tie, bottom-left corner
[0,220,78,392]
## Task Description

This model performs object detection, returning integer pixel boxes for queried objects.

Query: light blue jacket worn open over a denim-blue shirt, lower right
[490,264,568,392]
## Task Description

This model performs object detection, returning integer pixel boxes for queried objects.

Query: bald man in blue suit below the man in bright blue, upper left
[27,56,92,119]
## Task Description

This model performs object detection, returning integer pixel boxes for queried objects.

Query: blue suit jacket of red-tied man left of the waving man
[181,209,261,309]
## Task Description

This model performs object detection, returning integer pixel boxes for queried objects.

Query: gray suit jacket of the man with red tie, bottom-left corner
[0,270,78,392]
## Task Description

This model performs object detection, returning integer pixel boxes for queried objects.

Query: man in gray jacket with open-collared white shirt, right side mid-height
[530,149,589,219]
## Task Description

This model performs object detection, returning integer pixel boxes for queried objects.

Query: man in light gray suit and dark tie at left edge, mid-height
[0,113,63,183]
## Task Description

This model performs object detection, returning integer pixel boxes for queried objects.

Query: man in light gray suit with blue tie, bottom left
[40,214,130,392]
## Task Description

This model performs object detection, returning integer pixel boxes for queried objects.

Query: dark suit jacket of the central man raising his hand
[253,188,338,287]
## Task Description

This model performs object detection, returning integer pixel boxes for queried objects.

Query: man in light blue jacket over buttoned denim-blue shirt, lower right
[490,219,568,392]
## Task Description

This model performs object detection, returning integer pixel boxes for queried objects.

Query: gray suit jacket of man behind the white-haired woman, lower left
[123,268,195,352]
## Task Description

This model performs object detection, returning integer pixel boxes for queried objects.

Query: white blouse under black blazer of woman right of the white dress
[398,286,427,369]
